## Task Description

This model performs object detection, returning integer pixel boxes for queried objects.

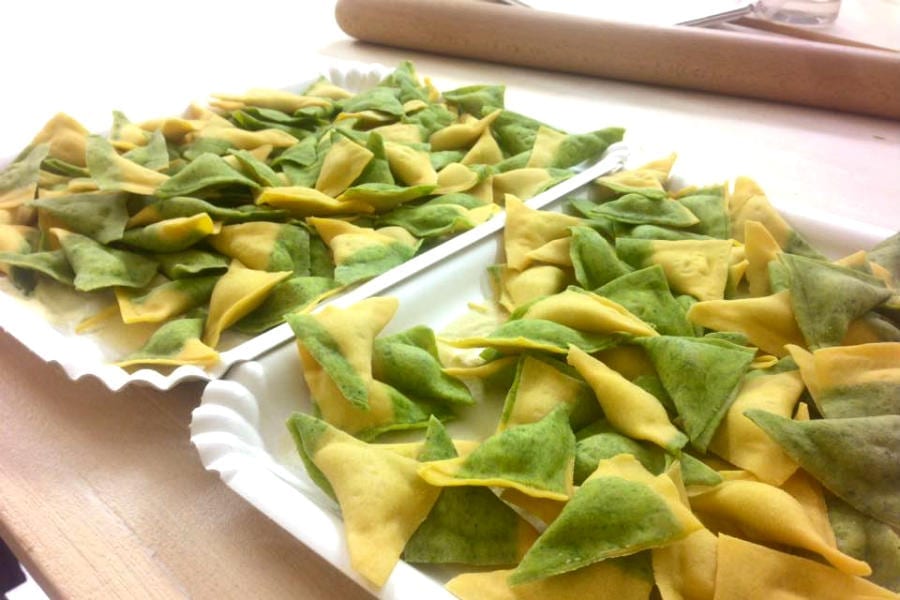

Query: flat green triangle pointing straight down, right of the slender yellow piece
[635,335,756,452]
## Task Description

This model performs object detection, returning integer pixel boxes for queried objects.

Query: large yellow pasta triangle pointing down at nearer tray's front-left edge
[292,413,440,587]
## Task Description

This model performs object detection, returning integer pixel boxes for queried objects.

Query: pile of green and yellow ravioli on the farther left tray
[0,62,623,366]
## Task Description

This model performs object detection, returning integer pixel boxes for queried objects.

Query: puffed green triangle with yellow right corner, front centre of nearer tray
[508,454,702,585]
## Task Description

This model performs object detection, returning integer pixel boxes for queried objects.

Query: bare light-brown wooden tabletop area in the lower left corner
[0,332,371,600]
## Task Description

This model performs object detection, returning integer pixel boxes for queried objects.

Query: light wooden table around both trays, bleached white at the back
[0,0,900,599]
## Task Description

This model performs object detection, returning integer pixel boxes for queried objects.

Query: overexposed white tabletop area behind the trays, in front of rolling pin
[0,0,900,230]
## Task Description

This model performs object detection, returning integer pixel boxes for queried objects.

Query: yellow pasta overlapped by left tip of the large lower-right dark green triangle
[709,371,804,485]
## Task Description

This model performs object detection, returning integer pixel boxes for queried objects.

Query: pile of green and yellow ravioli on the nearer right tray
[287,156,900,600]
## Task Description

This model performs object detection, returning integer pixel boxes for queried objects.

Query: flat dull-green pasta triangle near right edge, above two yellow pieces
[781,254,891,350]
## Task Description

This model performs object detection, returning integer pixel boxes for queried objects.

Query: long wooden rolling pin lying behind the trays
[335,0,900,120]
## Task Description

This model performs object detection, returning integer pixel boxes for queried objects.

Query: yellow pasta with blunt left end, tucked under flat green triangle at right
[687,290,806,356]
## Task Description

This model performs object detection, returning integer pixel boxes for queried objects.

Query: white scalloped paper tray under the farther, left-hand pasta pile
[0,61,628,391]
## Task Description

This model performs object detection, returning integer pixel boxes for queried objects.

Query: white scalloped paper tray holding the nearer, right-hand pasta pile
[191,161,894,600]
